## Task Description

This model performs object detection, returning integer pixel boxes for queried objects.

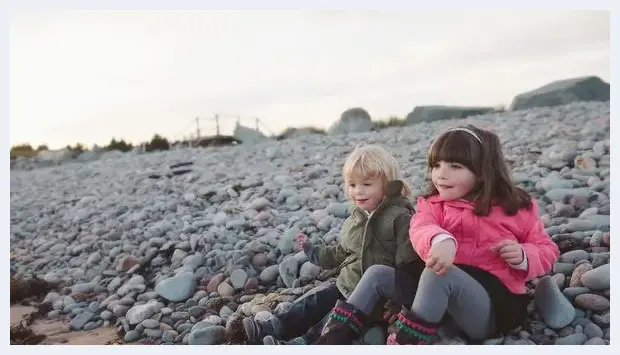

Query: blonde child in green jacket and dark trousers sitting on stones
[244,145,423,345]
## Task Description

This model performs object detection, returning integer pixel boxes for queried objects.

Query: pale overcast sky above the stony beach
[10,11,610,148]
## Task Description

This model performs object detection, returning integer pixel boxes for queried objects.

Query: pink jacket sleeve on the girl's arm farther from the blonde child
[518,200,560,280]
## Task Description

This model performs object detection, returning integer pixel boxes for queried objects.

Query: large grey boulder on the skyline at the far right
[511,76,610,110]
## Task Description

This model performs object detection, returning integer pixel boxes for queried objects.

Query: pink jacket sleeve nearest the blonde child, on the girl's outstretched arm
[409,197,458,261]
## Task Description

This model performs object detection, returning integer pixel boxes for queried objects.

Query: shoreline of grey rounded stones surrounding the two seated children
[10,102,610,345]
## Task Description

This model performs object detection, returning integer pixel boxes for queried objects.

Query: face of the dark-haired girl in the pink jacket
[431,160,476,201]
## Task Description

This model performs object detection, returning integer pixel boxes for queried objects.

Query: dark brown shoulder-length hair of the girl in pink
[425,125,532,216]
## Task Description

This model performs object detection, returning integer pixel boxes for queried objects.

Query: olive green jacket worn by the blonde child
[308,180,419,298]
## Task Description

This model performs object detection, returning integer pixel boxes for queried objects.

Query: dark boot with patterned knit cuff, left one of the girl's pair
[312,300,366,345]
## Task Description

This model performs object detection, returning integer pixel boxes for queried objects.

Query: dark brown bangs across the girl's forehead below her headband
[428,131,482,175]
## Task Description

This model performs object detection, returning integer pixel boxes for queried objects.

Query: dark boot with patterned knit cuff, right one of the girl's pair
[386,307,439,345]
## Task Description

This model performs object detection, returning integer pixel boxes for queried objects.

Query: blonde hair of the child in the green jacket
[342,144,411,197]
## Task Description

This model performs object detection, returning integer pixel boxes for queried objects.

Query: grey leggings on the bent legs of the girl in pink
[347,265,494,340]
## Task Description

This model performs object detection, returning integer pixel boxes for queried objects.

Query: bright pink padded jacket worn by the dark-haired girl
[409,195,560,293]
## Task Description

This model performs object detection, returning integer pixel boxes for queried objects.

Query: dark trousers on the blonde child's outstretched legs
[278,285,344,341]
